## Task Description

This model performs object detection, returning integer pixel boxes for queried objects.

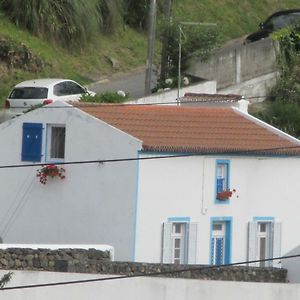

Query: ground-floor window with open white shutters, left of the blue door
[162,222,197,264]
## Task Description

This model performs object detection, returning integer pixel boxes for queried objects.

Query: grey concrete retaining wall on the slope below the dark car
[188,39,276,94]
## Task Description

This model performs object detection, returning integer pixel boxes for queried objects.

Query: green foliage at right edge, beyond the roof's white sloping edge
[255,24,300,138]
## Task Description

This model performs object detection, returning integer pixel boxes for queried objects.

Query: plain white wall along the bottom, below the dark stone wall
[0,271,300,300]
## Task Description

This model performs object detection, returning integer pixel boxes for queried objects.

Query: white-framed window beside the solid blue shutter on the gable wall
[47,125,66,161]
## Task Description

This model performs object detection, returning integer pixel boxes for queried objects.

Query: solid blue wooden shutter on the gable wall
[22,123,43,162]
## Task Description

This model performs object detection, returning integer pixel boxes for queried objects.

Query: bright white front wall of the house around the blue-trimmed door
[136,156,300,266]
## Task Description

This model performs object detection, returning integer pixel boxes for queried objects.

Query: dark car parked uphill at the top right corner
[245,9,300,43]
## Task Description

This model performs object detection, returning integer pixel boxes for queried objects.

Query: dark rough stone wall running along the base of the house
[0,248,287,282]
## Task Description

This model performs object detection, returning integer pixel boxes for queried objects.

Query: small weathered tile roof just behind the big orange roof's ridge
[180,93,243,103]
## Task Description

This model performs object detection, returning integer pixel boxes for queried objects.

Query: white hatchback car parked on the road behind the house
[5,78,95,116]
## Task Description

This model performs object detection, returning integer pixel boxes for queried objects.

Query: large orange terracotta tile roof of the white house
[76,104,300,154]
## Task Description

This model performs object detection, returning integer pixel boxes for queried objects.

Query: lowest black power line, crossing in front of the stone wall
[0,254,300,291]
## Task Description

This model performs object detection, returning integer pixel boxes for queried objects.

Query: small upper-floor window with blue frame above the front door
[215,159,230,203]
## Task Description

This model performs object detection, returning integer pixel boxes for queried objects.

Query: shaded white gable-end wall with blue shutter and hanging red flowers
[0,104,141,260]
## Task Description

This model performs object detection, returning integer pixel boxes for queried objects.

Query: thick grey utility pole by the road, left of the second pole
[145,0,156,96]
